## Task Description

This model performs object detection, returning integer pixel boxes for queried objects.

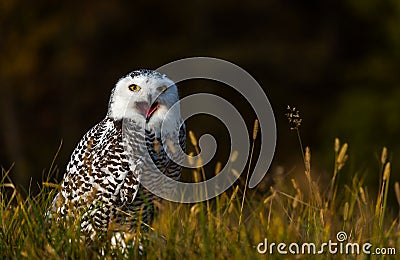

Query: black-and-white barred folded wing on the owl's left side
[53,118,138,234]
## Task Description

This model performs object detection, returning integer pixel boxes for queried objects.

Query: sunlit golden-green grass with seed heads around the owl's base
[0,117,400,259]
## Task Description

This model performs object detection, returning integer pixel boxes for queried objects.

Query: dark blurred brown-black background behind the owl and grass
[0,0,400,195]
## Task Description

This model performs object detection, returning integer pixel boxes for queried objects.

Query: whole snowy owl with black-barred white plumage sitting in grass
[50,70,186,242]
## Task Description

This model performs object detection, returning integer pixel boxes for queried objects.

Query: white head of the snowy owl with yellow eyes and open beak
[107,70,180,129]
